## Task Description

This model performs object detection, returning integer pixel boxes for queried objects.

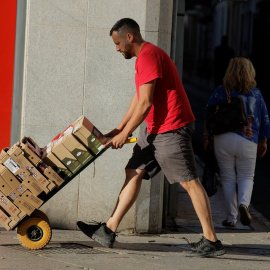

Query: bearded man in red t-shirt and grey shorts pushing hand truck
[77,18,225,257]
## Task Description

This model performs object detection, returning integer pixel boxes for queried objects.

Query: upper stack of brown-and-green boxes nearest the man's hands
[42,116,107,174]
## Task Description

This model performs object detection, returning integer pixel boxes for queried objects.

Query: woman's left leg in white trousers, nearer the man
[214,133,238,222]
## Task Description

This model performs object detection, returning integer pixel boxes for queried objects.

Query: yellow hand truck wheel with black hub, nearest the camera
[17,217,52,249]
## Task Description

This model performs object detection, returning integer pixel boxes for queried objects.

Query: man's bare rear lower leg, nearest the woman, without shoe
[180,178,217,242]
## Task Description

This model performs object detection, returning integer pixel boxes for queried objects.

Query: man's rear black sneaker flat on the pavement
[187,237,226,257]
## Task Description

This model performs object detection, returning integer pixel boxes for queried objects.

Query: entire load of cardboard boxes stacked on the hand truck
[0,116,107,230]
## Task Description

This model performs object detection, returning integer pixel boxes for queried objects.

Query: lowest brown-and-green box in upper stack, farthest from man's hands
[42,152,73,180]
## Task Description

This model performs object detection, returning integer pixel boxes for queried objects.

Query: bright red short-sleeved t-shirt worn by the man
[135,42,195,134]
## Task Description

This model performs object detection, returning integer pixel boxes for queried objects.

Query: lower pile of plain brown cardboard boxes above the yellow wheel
[0,138,59,230]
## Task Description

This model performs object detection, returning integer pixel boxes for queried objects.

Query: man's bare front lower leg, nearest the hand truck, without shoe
[106,169,146,232]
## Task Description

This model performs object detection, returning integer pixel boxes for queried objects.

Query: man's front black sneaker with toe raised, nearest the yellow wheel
[77,221,117,248]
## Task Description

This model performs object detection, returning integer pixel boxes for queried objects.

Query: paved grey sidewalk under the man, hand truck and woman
[0,157,270,270]
